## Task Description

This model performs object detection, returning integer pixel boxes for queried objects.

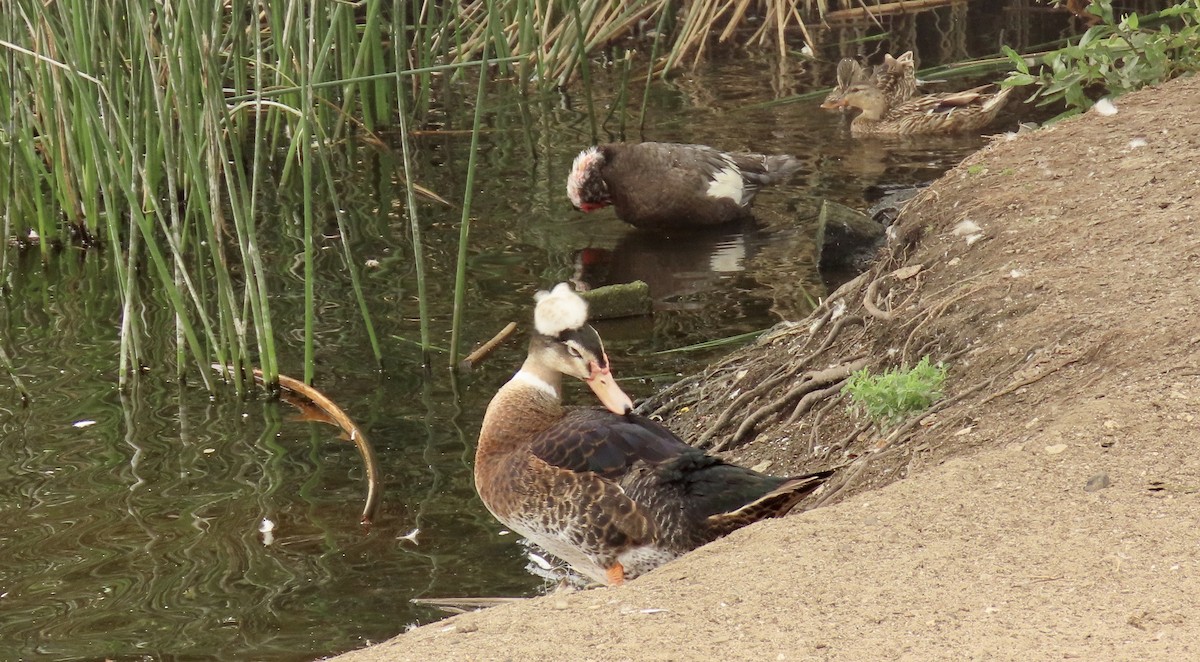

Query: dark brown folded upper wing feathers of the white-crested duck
[529,409,702,480]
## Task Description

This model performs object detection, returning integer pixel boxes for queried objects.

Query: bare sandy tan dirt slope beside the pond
[338,78,1200,661]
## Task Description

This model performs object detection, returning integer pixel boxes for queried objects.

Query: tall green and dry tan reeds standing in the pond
[0,0,888,389]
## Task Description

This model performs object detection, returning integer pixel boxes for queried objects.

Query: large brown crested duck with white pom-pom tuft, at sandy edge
[474,283,832,585]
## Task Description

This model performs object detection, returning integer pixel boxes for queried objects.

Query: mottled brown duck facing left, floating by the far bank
[836,82,1013,137]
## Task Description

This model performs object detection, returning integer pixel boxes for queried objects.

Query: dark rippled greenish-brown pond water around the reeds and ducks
[0,3,1080,660]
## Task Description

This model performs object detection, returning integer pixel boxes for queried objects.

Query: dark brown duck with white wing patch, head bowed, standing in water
[566,143,802,230]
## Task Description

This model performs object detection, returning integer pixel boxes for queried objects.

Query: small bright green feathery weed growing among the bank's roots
[842,356,946,429]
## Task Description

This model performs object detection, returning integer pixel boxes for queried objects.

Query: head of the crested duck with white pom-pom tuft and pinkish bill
[523,283,634,415]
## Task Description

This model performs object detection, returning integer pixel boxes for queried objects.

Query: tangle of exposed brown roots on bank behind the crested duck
[641,206,1094,505]
